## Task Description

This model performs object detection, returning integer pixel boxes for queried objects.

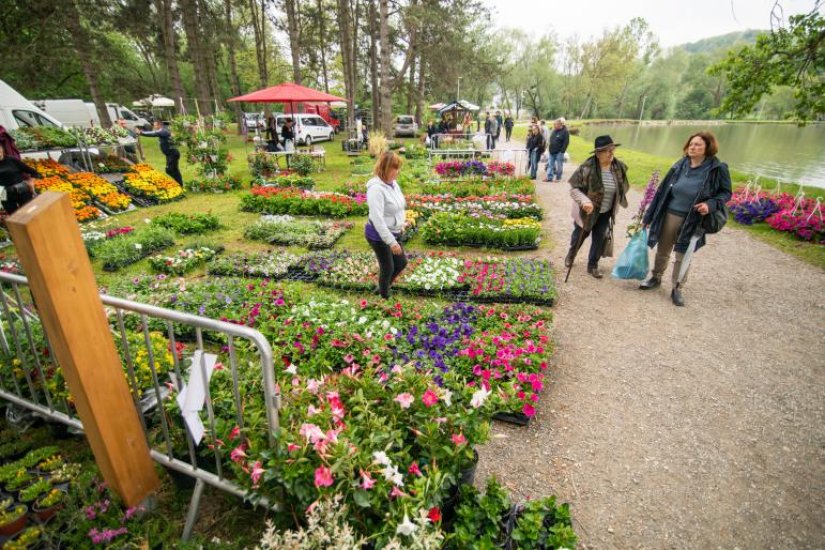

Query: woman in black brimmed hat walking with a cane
[564,136,629,279]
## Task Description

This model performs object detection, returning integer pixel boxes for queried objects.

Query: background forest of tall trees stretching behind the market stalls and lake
[0,0,812,132]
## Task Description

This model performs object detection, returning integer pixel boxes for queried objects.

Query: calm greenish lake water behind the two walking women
[581,123,825,188]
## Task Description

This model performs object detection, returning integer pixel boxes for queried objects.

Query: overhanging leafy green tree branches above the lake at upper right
[710,9,825,122]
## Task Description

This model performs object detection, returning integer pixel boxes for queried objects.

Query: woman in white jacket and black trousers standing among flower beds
[364,151,407,299]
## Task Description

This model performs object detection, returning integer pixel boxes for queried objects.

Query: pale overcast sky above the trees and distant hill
[483,0,825,47]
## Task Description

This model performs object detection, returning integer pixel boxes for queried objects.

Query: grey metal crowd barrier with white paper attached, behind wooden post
[0,272,280,540]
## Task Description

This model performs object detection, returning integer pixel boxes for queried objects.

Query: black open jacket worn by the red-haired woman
[642,156,731,253]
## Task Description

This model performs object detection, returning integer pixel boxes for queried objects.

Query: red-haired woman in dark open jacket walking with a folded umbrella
[639,132,731,306]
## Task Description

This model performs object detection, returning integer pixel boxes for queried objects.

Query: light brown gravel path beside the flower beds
[478,149,825,549]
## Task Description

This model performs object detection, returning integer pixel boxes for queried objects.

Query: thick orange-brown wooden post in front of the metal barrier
[6,192,160,506]
